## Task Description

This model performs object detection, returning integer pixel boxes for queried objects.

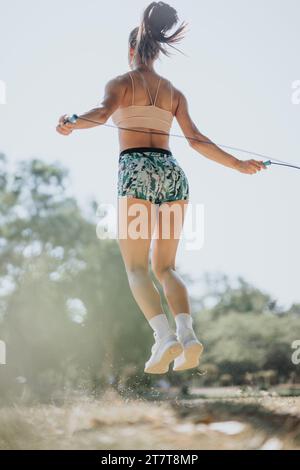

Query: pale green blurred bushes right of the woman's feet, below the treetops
[197,311,300,384]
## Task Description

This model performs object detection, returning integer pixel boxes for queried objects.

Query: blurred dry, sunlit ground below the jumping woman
[0,392,300,450]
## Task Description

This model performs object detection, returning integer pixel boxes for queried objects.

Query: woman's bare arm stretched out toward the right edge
[176,90,266,175]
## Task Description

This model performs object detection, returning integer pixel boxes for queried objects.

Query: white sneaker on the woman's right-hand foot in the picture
[173,329,203,372]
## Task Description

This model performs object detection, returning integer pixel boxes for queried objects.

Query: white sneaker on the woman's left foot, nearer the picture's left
[144,333,183,374]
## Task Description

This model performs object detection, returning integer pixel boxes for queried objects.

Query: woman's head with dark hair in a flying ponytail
[129,2,186,64]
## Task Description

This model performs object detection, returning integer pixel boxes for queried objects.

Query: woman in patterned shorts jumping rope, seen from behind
[56,2,265,374]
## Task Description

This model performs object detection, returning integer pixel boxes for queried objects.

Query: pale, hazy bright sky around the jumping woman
[0,0,300,305]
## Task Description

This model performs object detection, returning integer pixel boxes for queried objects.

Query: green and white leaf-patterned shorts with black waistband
[118,147,189,205]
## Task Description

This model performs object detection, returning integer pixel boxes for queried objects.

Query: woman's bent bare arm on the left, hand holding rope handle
[56,75,126,135]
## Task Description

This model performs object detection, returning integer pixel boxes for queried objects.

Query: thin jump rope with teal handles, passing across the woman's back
[64,114,300,170]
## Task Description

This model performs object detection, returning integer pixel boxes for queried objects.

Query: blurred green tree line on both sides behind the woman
[0,155,300,400]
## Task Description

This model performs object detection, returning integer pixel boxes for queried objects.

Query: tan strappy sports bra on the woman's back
[111,72,174,133]
